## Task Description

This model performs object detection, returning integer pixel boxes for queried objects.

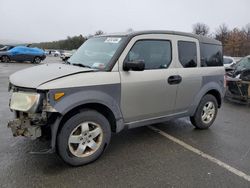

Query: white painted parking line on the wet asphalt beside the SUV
[148,126,250,182]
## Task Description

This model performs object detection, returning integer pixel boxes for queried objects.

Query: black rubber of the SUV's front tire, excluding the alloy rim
[57,110,111,166]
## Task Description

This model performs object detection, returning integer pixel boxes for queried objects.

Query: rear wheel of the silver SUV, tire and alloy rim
[190,94,218,129]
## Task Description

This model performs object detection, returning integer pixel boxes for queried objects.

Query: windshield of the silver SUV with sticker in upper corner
[68,37,123,70]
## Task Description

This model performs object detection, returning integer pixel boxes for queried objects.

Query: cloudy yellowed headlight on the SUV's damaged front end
[10,92,40,113]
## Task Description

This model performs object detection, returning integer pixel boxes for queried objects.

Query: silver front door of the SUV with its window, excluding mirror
[119,34,177,123]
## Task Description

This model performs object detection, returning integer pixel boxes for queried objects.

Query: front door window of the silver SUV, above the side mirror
[125,40,172,70]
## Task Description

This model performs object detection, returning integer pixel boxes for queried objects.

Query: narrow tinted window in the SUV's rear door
[178,41,197,68]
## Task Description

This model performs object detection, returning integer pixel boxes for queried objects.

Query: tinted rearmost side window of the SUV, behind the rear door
[200,43,223,67]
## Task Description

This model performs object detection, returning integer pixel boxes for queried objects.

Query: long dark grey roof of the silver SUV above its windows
[99,30,221,45]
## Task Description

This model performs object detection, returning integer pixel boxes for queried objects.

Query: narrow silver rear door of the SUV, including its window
[175,36,204,112]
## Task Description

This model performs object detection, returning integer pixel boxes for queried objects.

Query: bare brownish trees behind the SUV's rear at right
[193,23,250,57]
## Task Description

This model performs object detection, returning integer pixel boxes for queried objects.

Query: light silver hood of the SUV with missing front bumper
[9,63,94,88]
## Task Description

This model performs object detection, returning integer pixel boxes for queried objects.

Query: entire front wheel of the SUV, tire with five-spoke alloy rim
[57,110,111,166]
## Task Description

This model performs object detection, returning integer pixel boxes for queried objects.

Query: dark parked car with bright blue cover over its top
[0,46,46,63]
